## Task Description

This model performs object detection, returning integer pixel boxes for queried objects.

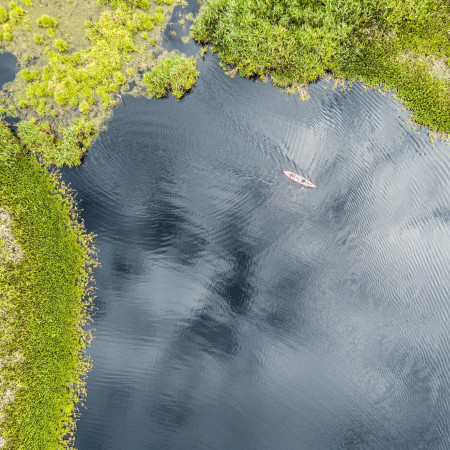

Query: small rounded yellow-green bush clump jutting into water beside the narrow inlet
[144,55,199,99]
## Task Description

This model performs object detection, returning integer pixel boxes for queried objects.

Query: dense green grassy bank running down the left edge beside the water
[0,123,94,450]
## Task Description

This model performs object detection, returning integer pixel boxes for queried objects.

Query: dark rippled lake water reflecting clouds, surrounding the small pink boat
[64,56,450,450]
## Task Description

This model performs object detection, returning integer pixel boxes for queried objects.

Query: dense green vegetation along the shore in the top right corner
[192,0,450,133]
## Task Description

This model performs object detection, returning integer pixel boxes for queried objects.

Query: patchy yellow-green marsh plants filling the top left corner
[0,0,199,166]
